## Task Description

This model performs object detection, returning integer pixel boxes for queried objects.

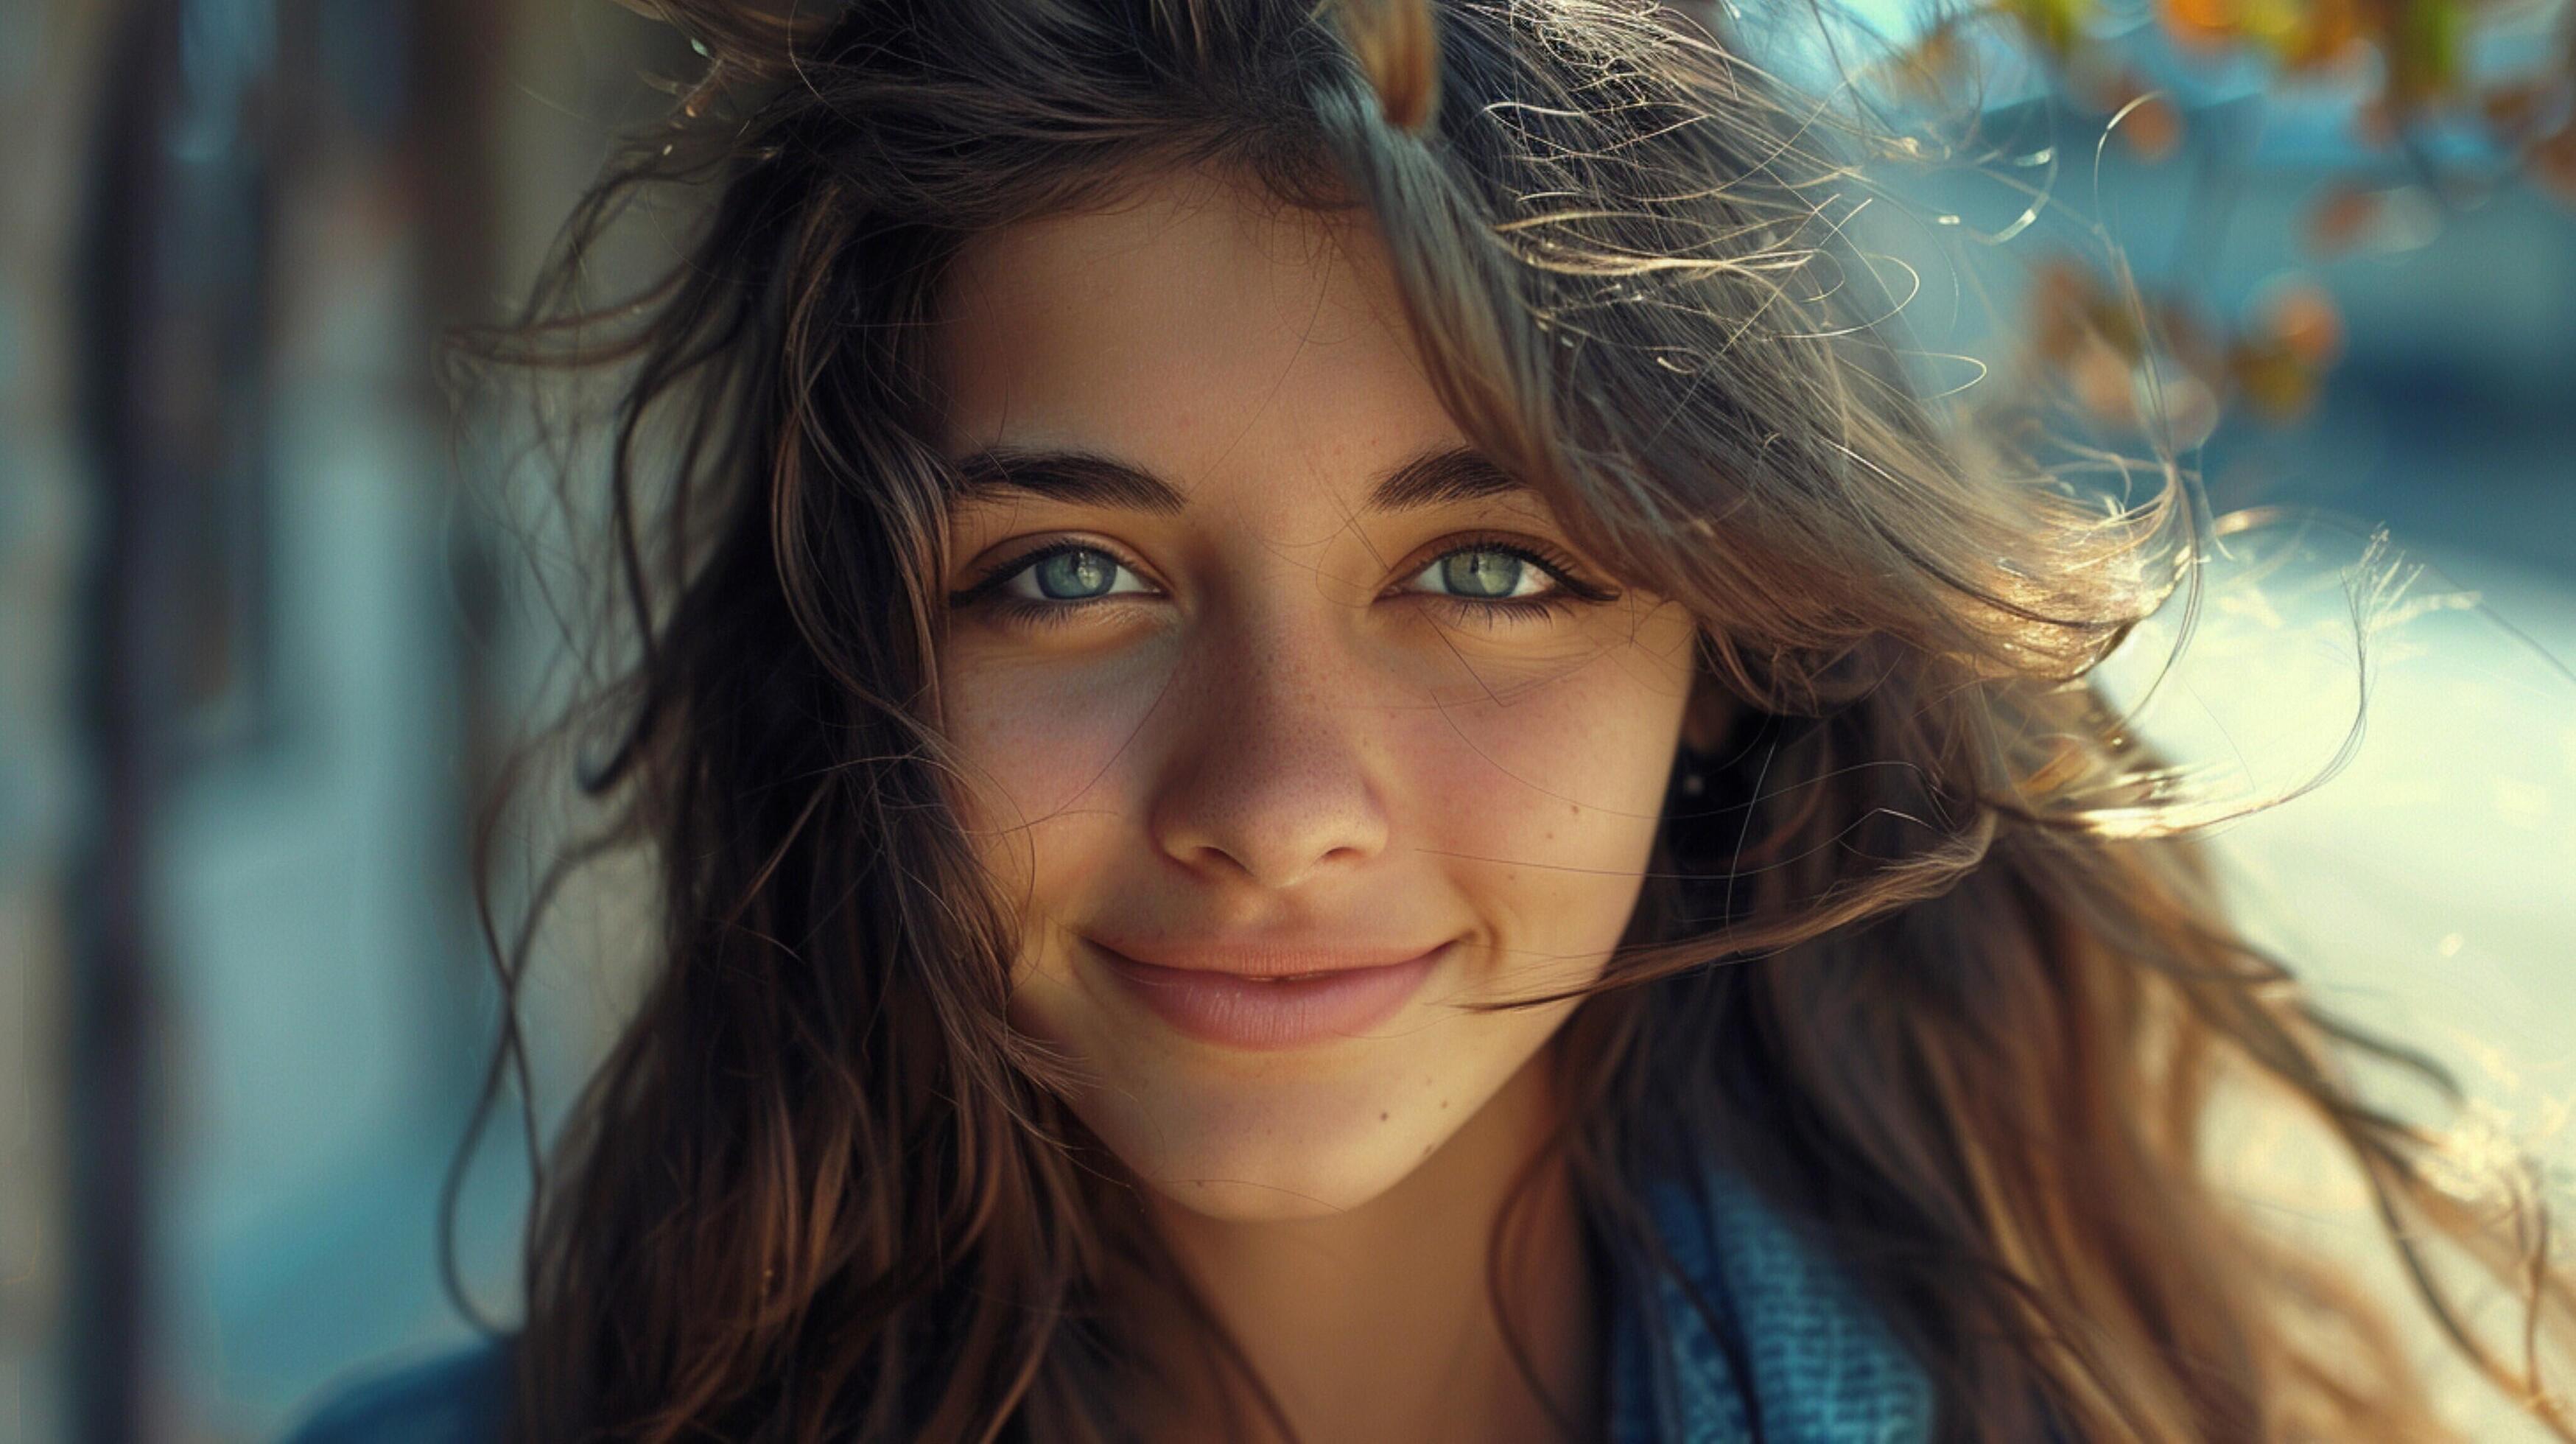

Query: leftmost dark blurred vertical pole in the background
[64,0,276,1444]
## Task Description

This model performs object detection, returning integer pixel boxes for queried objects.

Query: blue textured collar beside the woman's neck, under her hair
[1610,1174,1934,1444]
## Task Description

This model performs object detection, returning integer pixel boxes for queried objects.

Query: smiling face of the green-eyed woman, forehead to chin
[935,178,1695,1220]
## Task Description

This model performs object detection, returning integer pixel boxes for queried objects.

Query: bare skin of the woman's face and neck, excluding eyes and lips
[933,175,1698,1442]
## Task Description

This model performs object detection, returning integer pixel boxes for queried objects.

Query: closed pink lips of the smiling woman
[1095,944,1447,1052]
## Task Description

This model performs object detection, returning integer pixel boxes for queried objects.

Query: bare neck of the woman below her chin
[1146,1050,1597,1444]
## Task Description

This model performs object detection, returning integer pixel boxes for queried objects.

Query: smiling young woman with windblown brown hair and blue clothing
[292,0,2576,1442]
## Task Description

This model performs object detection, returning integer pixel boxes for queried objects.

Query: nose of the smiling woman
[1146,609,1389,890]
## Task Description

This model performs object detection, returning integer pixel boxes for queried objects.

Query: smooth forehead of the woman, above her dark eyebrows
[933,173,1494,528]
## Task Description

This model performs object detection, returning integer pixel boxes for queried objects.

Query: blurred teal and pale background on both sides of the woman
[0,0,2576,1442]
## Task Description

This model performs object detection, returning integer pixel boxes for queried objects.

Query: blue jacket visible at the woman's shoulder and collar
[291,1174,1932,1444]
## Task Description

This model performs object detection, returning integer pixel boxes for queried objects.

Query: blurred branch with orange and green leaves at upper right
[1862,0,2576,433]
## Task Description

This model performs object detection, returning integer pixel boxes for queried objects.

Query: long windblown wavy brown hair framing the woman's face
[453,0,2576,1442]
